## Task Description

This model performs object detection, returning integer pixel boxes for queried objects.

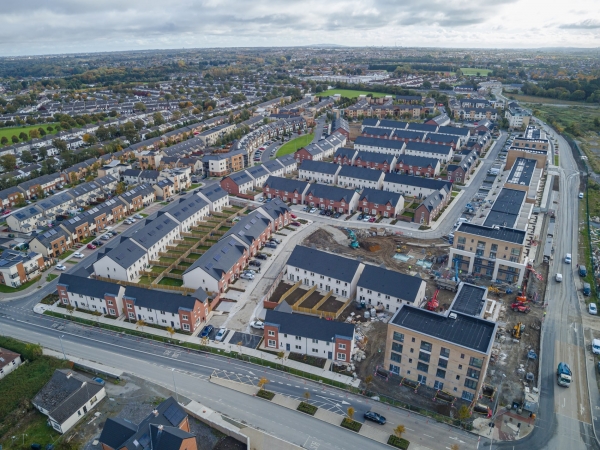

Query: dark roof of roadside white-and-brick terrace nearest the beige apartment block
[265,309,354,342]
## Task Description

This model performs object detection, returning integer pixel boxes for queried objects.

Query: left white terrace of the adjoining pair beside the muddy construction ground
[285,245,364,298]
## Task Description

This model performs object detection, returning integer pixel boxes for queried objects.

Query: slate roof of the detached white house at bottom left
[32,369,104,424]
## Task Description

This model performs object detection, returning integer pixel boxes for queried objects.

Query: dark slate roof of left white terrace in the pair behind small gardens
[287,245,360,283]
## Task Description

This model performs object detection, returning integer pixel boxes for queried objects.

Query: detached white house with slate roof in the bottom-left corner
[31,369,106,433]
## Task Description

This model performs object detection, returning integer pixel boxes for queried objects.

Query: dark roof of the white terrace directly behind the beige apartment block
[357,264,425,303]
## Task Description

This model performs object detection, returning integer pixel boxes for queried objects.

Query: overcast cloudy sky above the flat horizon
[0,0,600,56]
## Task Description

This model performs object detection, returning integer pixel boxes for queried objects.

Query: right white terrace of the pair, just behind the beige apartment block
[356,264,426,312]
